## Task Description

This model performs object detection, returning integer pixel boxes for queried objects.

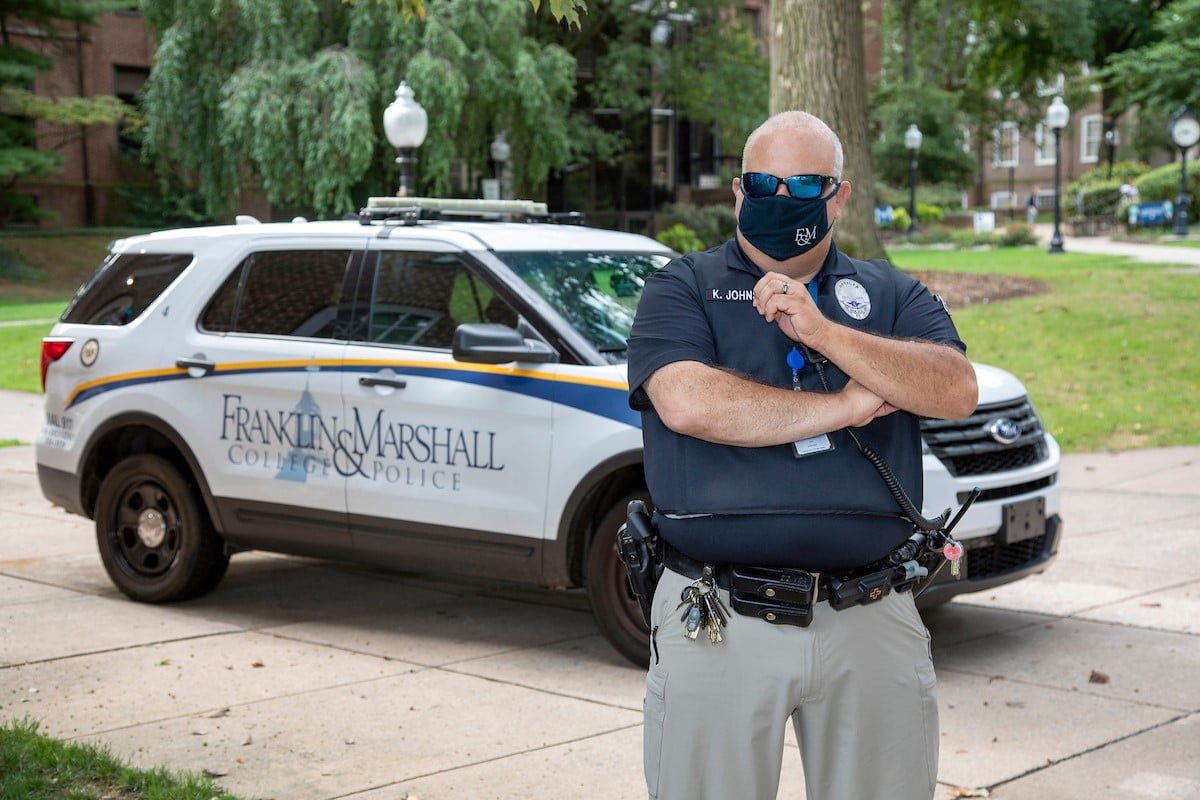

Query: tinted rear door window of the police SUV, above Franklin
[200,249,350,339]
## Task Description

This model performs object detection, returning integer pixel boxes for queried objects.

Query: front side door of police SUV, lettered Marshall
[343,239,557,578]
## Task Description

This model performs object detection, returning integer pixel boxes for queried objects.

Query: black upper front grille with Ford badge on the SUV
[920,397,1049,477]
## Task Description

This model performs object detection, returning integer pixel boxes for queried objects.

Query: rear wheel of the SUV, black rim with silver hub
[96,453,229,603]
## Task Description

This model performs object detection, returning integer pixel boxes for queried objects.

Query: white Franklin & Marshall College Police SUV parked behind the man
[37,198,1060,663]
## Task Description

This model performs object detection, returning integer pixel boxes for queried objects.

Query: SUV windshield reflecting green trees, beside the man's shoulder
[497,251,671,354]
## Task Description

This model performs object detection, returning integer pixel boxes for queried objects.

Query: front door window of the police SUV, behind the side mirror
[367,252,517,349]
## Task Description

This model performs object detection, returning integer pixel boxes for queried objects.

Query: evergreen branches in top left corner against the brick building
[0,0,134,227]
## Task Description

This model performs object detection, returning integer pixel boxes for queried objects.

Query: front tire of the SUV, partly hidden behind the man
[586,491,650,668]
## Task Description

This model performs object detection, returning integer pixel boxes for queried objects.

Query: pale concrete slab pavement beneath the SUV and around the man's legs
[0,392,1200,800]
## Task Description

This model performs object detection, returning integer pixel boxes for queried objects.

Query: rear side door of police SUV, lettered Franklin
[172,239,362,557]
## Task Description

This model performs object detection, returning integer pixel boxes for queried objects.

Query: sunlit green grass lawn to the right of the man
[893,248,1200,452]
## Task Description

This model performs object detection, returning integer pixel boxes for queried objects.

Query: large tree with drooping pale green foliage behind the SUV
[143,0,574,216]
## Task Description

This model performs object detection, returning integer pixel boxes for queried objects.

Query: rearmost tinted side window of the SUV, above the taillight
[62,253,192,325]
